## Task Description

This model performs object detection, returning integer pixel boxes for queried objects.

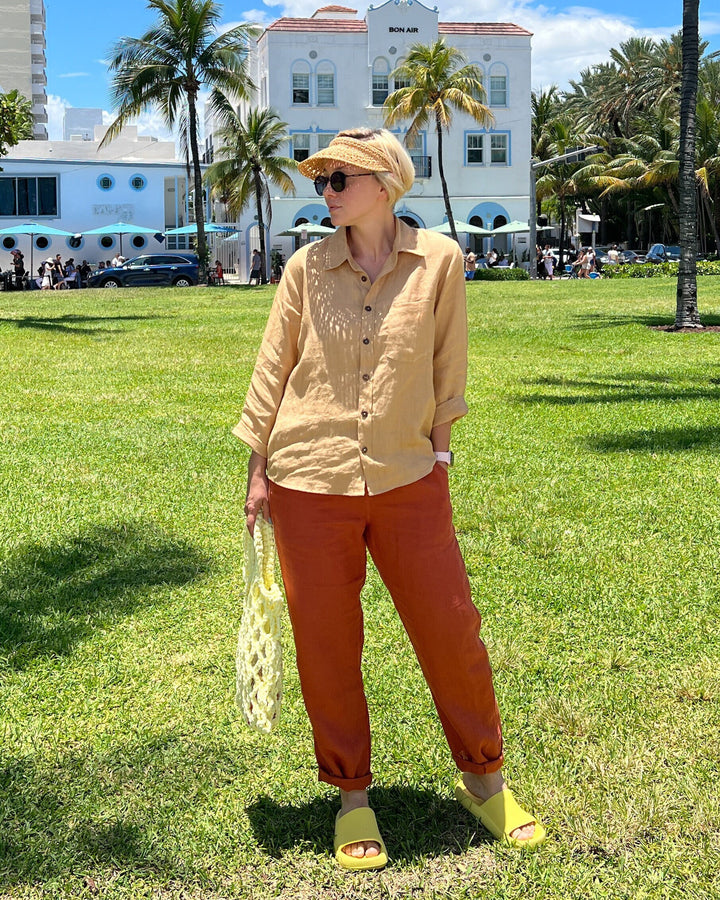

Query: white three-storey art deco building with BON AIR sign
[206,0,531,269]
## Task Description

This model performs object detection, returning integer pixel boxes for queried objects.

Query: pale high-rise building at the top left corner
[0,0,48,140]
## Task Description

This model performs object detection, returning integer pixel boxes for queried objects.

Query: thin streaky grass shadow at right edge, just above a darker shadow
[512,372,720,406]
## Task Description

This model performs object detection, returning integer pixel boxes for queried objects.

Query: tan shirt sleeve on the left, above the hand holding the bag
[232,253,304,456]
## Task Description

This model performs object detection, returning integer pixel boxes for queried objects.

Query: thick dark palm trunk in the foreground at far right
[675,0,702,328]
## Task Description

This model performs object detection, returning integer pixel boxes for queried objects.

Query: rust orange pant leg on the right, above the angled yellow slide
[366,465,502,774]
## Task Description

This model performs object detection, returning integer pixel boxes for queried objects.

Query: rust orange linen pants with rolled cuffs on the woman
[269,465,502,791]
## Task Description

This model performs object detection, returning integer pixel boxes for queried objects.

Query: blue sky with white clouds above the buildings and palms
[45,0,720,137]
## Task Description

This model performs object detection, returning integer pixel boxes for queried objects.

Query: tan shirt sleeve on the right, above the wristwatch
[433,247,468,427]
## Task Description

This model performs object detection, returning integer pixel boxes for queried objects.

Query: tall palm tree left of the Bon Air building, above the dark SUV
[103,0,257,281]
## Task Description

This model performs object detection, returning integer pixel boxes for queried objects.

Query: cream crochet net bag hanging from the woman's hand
[235,515,283,734]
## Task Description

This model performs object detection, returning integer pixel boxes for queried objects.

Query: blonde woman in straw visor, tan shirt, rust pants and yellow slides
[234,129,544,869]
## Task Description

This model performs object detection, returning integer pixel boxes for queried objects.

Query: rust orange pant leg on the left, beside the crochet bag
[269,483,372,791]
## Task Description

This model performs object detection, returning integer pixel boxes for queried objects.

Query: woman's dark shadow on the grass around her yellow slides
[247,786,493,862]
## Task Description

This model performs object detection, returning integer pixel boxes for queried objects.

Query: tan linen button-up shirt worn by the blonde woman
[233,219,467,495]
